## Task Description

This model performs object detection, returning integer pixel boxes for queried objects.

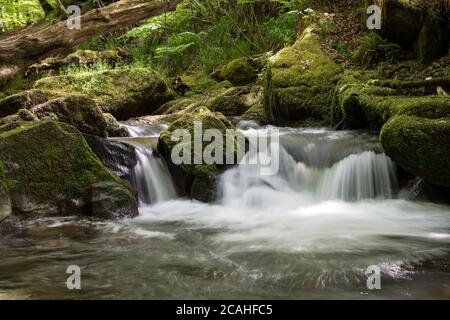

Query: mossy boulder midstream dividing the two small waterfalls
[158,106,246,202]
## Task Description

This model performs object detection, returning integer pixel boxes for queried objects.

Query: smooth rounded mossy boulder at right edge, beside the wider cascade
[381,114,450,187]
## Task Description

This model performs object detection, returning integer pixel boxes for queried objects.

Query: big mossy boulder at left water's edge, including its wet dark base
[0,121,137,218]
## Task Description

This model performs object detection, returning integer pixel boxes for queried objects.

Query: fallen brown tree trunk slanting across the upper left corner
[0,0,183,83]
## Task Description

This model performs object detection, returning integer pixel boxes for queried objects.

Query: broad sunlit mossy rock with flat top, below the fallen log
[34,68,174,120]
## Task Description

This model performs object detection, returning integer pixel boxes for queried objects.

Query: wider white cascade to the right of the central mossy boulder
[221,136,397,207]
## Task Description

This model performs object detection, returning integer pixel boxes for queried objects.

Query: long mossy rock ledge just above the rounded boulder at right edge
[333,73,450,130]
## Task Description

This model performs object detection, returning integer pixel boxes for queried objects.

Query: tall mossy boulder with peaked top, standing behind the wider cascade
[264,28,342,124]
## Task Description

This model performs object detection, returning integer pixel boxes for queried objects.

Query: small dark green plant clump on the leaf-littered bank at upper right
[354,32,403,69]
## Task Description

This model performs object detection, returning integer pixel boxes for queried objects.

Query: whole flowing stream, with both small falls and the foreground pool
[0,123,450,299]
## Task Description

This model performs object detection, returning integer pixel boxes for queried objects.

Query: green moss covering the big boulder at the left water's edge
[0,121,119,209]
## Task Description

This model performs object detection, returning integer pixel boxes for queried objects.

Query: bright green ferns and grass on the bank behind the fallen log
[78,0,311,75]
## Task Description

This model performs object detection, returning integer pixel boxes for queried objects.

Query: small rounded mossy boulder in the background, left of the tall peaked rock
[211,57,258,86]
